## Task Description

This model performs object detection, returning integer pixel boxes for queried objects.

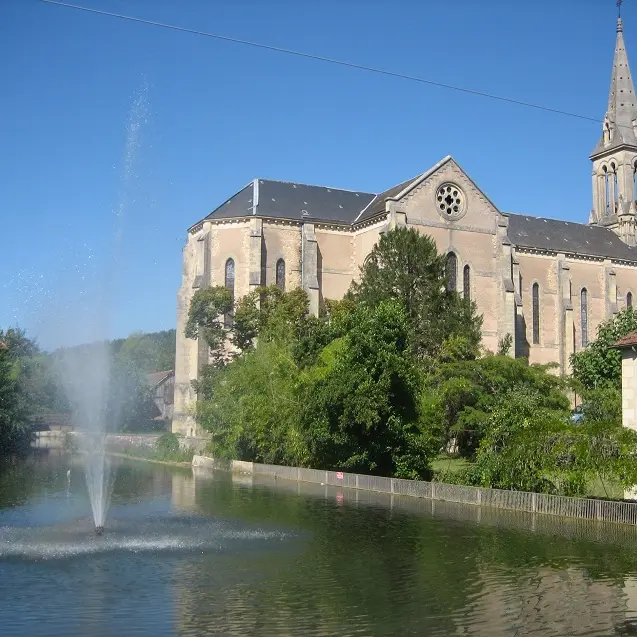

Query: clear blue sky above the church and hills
[0,0,637,347]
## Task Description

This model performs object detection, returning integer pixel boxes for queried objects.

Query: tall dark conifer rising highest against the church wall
[349,228,482,357]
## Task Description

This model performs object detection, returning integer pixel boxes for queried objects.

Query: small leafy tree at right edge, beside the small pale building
[571,307,637,389]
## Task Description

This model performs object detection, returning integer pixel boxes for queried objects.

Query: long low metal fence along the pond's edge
[204,456,637,525]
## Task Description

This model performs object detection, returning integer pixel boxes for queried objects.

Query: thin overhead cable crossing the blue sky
[38,0,603,124]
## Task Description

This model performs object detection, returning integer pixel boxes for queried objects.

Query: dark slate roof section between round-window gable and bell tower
[506,213,637,261]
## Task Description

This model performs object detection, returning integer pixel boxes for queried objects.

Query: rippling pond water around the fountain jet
[0,453,637,637]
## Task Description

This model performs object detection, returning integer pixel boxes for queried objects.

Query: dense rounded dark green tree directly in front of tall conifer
[301,301,440,478]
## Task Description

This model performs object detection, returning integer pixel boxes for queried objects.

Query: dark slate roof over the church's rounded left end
[206,179,375,224]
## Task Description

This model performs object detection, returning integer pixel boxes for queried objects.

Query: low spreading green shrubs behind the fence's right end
[441,387,637,496]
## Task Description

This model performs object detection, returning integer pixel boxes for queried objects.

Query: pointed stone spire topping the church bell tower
[591,18,637,157]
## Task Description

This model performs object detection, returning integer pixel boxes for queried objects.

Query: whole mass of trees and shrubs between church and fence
[187,229,637,494]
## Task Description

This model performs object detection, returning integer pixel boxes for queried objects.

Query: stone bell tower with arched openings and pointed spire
[589,15,637,246]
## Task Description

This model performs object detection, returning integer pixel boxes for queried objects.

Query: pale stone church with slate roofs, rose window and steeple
[172,18,637,436]
